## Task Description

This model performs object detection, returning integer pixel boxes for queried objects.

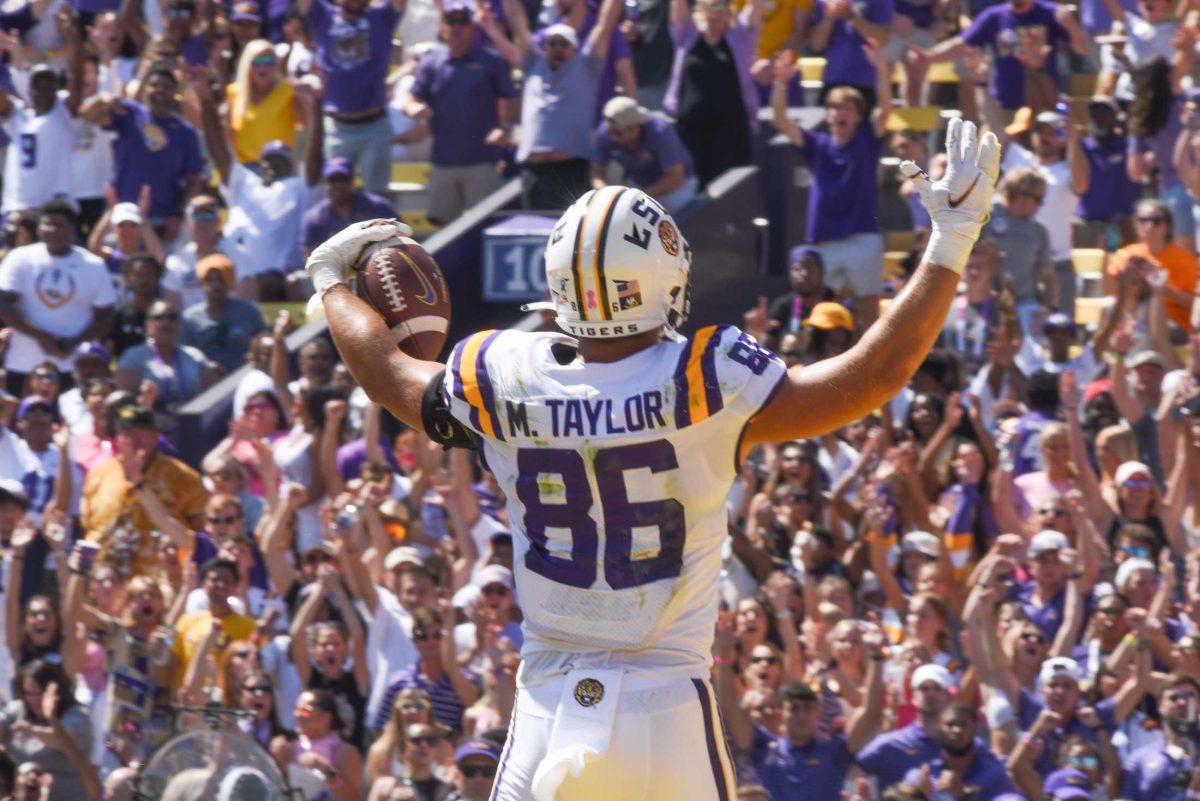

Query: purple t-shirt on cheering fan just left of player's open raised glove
[800,122,880,242]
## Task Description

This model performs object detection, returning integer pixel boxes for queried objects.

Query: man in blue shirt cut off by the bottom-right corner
[1120,675,1200,801]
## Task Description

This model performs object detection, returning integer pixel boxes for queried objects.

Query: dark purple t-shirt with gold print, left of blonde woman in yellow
[106,100,204,221]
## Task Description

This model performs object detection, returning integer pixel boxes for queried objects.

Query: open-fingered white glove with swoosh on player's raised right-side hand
[900,118,1000,276]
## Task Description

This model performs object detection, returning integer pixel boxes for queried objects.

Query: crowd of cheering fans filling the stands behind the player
[0,0,1200,801]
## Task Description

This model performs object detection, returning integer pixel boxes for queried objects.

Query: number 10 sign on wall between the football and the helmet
[484,215,554,302]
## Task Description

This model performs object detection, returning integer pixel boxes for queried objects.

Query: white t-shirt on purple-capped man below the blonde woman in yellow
[221,162,317,278]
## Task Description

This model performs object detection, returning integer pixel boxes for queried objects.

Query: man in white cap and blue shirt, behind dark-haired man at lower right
[856,663,954,788]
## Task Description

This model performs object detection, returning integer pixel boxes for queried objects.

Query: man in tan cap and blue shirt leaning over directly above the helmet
[592,97,700,213]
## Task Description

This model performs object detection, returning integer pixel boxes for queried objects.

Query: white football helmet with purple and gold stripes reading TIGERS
[526,186,691,338]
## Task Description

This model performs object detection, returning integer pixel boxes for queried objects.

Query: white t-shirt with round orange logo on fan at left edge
[0,244,116,373]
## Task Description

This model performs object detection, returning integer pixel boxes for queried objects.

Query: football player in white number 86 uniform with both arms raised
[307,120,1000,801]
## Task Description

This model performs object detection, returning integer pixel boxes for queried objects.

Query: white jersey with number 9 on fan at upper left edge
[0,92,77,213]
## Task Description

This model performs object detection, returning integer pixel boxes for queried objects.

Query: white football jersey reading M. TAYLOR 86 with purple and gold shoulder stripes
[444,326,786,680]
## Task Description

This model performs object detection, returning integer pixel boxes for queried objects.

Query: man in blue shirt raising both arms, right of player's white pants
[715,626,886,801]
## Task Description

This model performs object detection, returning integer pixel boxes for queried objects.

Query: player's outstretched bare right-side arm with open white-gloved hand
[744,119,1000,446]
